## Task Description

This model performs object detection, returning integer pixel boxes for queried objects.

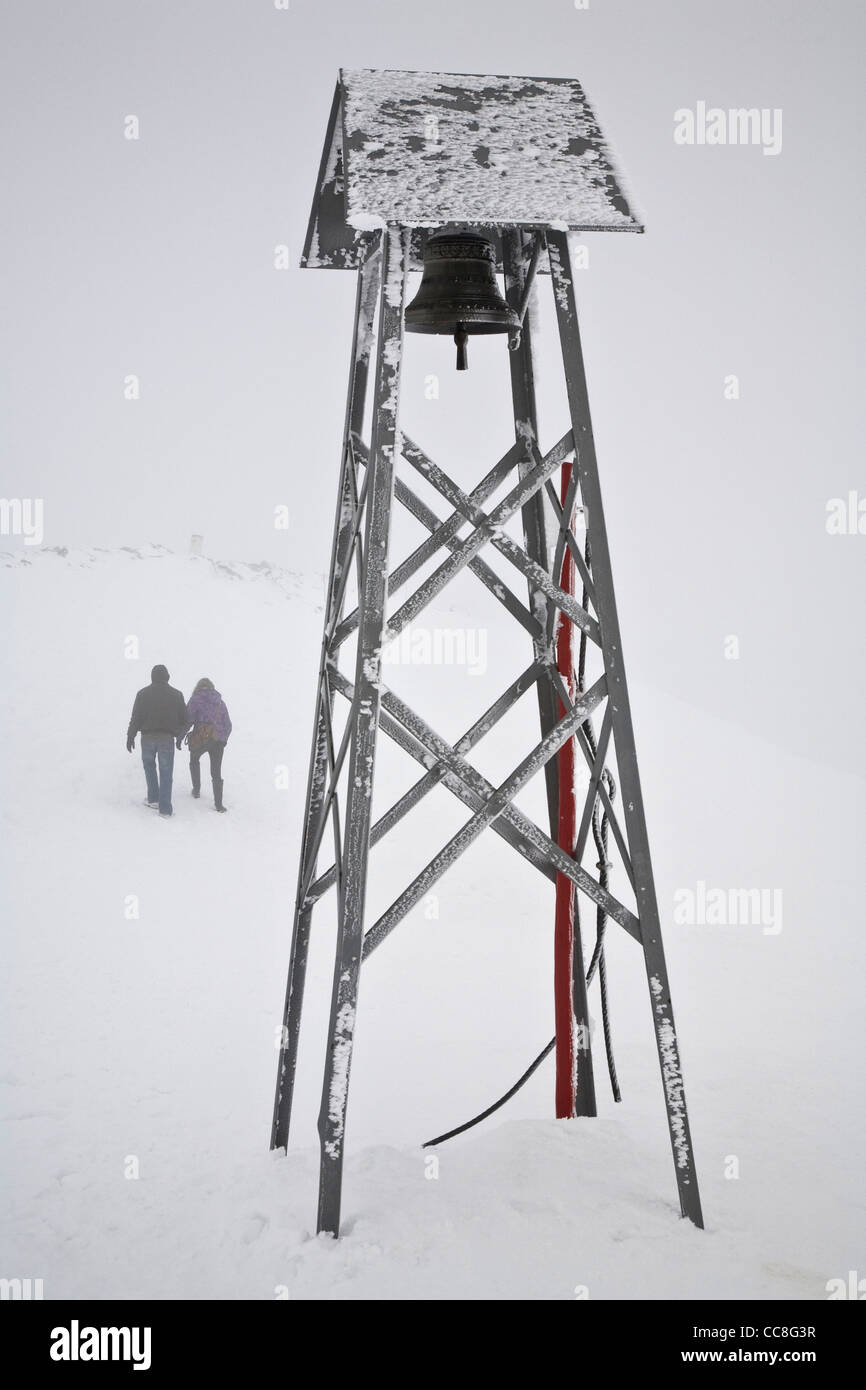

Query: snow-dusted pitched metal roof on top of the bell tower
[302,68,644,270]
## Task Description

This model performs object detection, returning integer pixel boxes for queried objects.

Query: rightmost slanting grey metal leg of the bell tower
[548,232,703,1226]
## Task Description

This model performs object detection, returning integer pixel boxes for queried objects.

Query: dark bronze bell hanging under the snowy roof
[406,232,520,371]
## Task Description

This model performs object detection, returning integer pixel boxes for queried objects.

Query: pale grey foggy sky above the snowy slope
[0,0,866,778]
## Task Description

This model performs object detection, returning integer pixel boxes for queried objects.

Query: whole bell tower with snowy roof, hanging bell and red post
[271,70,702,1236]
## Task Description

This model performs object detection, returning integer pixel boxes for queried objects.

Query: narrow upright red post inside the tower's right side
[553,461,577,1119]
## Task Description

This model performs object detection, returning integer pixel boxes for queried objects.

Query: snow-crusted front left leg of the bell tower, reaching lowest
[317,228,407,1236]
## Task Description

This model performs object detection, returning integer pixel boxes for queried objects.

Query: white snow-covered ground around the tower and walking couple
[0,548,866,1298]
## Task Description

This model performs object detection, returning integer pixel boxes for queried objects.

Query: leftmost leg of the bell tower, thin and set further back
[271,240,381,1148]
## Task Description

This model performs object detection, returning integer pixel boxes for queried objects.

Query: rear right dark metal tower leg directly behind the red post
[502,229,598,1116]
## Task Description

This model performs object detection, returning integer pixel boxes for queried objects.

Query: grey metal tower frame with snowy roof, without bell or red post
[271,72,703,1236]
